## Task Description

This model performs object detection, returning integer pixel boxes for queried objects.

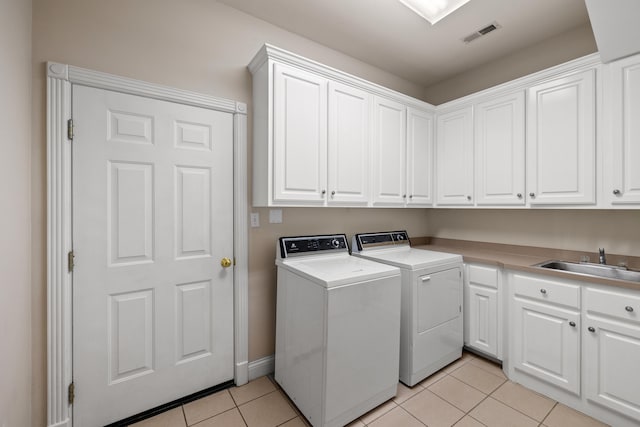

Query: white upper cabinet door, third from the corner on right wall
[527,70,596,205]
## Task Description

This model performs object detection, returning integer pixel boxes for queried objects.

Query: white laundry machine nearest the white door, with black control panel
[275,234,401,426]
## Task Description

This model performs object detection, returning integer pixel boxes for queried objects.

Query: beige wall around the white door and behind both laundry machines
[31,0,426,427]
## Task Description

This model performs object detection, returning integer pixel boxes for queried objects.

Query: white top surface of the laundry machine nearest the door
[276,254,400,288]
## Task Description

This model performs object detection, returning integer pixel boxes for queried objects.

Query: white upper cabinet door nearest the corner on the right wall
[436,107,473,205]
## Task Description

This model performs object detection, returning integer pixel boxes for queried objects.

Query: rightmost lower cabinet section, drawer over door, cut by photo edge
[583,287,640,423]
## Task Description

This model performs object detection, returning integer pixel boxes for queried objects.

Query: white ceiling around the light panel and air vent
[218,0,589,87]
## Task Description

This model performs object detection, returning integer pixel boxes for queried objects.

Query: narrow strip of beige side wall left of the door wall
[0,0,31,427]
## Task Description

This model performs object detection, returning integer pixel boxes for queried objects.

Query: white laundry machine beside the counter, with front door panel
[352,231,464,386]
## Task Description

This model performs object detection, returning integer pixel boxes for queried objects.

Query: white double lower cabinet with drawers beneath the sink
[505,272,640,427]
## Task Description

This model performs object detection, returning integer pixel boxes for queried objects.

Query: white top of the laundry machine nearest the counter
[358,246,462,270]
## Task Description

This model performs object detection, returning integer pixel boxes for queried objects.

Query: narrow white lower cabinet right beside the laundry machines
[464,264,502,360]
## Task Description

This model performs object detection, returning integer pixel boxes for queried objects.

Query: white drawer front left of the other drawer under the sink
[513,274,580,308]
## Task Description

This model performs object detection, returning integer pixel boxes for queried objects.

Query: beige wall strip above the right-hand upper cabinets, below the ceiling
[423,24,598,105]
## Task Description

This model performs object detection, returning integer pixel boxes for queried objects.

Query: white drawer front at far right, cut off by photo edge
[585,288,640,323]
